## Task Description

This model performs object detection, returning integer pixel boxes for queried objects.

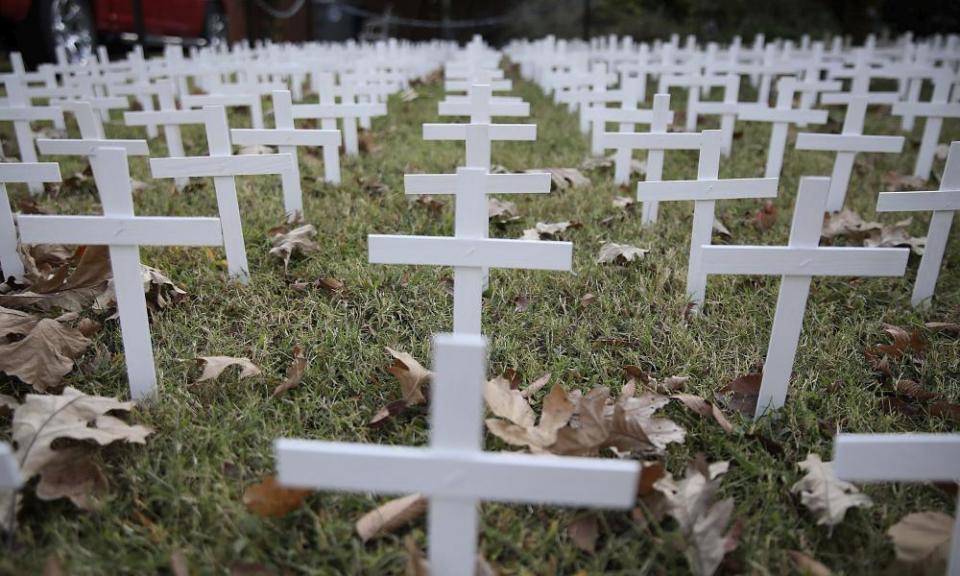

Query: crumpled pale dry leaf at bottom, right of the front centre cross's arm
[654,461,737,576]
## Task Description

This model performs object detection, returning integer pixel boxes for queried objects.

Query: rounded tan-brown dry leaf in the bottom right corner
[887,512,953,574]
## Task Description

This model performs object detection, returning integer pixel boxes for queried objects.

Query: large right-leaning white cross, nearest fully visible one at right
[700,177,910,417]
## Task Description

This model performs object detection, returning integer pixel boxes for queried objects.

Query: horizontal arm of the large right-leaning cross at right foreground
[701,246,910,276]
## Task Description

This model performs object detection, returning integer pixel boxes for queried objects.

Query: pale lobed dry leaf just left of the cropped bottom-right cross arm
[790,453,873,526]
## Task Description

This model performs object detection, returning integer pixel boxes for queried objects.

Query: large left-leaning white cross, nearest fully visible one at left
[18,147,223,400]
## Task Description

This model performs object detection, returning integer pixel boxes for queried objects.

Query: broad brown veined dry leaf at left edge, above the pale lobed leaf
[0,307,90,392]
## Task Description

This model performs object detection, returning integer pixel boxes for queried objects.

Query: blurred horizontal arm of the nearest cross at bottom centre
[274,439,640,508]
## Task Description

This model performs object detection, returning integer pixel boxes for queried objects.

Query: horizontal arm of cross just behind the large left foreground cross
[150,154,295,178]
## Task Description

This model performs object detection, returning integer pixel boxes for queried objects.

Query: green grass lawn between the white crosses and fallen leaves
[0,65,960,575]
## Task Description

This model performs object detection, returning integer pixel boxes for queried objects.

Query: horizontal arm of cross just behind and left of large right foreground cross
[637,178,777,202]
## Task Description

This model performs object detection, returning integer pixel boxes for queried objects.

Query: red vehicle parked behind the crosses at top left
[0,0,229,65]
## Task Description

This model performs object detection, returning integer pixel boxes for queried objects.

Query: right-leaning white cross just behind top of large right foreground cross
[796,94,904,212]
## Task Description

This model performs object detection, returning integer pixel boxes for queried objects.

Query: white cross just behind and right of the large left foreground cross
[150,106,295,284]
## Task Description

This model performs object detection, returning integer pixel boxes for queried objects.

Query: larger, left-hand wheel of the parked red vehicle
[16,0,97,66]
